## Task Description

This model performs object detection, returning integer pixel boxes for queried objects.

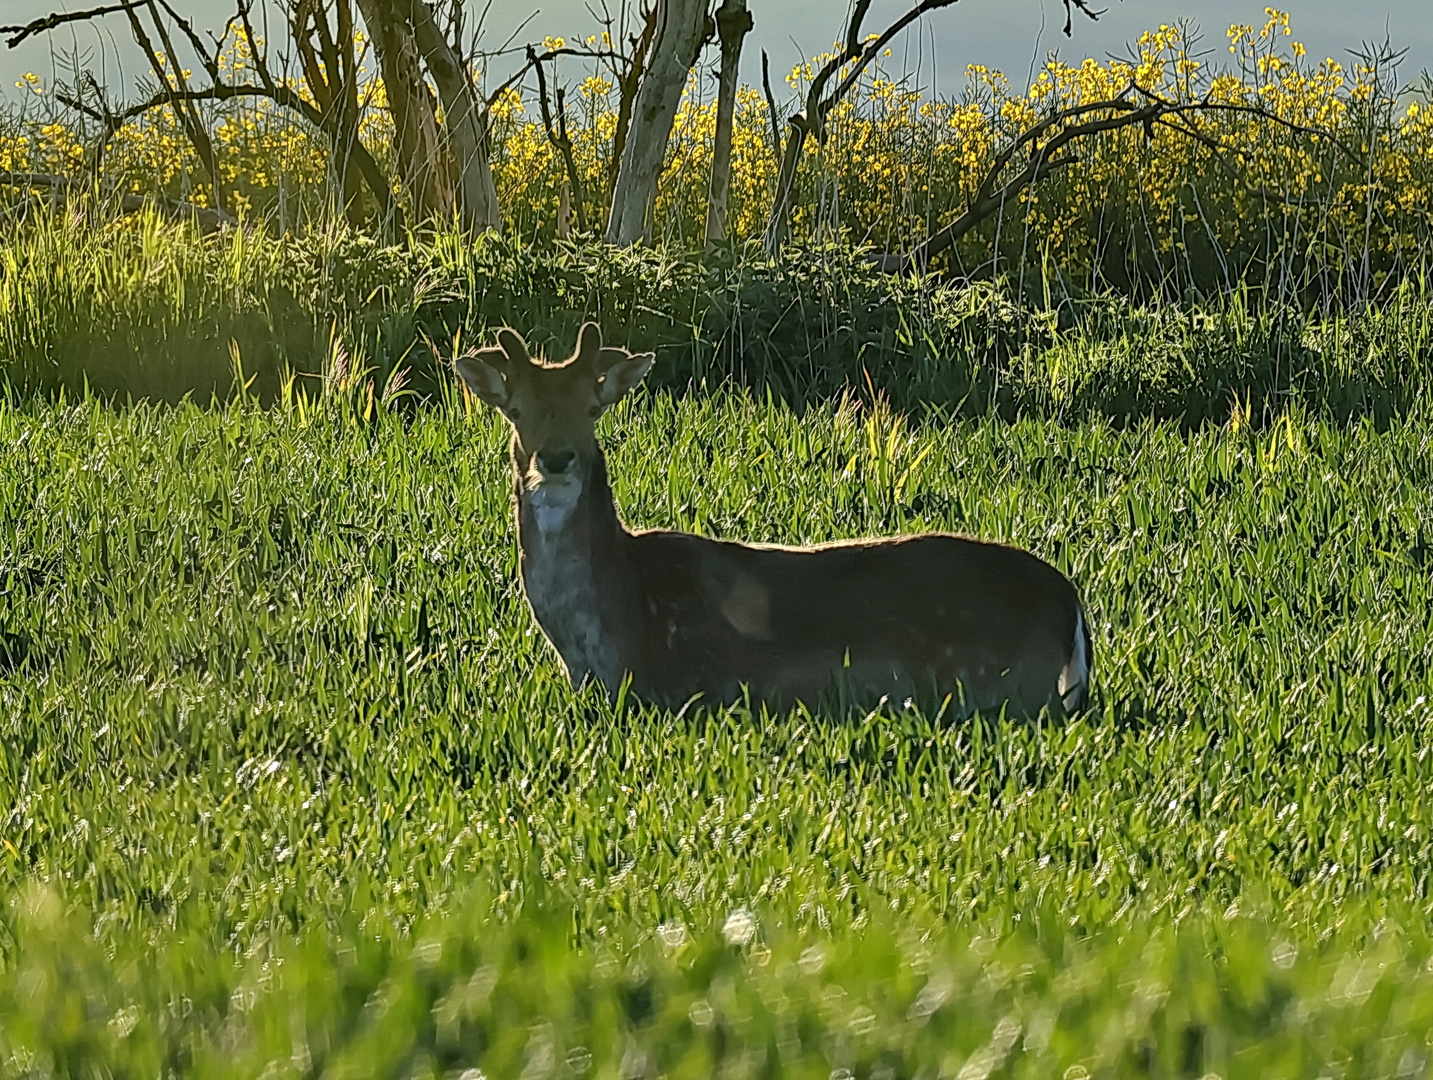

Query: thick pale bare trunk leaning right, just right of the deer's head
[608,0,709,244]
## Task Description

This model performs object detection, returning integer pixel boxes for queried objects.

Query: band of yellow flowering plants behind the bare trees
[0,9,1433,286]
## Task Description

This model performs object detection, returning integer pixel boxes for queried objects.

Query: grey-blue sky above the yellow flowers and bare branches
[0,0,1433,107]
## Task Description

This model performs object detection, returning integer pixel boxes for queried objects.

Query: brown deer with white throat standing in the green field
[457,322,1091,713]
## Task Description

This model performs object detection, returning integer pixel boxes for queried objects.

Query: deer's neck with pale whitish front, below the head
[517,447,629,690]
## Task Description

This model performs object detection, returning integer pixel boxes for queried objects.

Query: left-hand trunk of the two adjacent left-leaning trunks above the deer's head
[358,0,453,218]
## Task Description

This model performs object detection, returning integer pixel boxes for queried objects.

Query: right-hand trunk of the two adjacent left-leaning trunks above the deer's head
[408,0,503,233]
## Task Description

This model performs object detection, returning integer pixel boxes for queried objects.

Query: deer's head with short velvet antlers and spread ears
[457,322,655,531]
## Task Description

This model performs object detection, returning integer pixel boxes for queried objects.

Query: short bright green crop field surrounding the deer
[0,263,1433,1080]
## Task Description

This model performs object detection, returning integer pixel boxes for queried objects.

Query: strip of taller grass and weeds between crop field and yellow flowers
[0,212,1433,425]
